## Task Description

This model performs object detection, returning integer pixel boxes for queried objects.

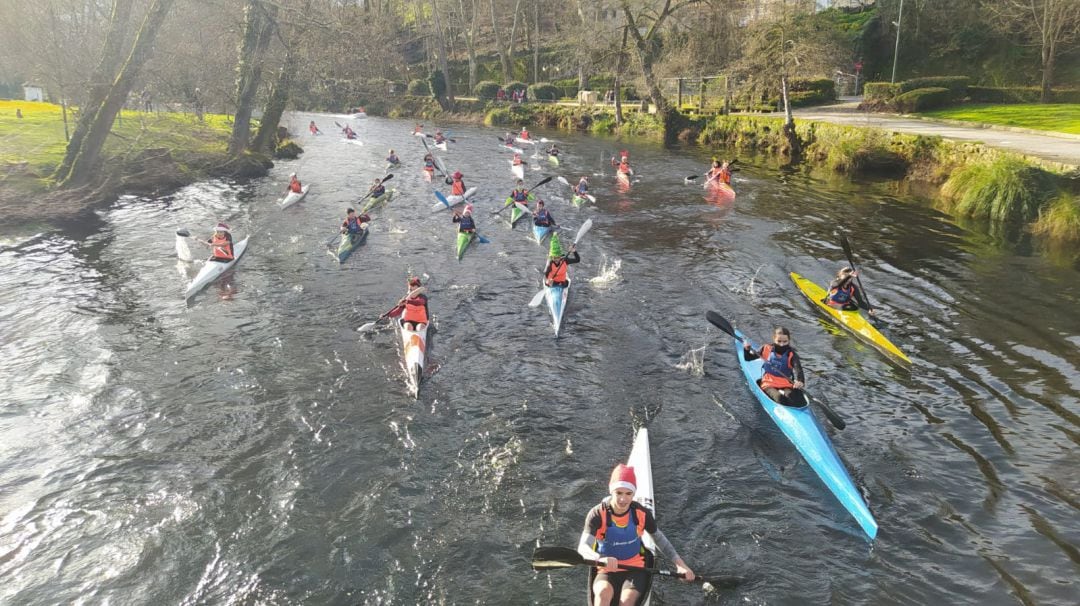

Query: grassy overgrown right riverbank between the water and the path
[375,97,1080,248]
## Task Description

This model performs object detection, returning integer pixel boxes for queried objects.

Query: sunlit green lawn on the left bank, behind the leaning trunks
[0,99,231,189]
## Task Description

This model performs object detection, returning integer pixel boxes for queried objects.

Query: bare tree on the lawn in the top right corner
[988,0,1080,103]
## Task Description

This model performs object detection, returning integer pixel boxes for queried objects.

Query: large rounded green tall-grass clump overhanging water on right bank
[942,157,1057,221]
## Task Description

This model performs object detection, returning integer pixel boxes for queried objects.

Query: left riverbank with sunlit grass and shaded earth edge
[0,100,273,229]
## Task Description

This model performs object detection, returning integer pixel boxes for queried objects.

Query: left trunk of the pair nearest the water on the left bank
[228,0,278,156]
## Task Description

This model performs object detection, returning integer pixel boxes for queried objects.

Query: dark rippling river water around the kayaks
[0,116,1080,606]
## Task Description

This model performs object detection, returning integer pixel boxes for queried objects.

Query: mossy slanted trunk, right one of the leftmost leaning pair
[60,0,173,188]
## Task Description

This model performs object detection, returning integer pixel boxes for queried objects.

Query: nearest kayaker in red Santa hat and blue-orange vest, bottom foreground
[578,463,693,605]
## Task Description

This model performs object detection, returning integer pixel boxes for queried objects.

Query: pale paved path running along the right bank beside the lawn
[795,105,1080,166]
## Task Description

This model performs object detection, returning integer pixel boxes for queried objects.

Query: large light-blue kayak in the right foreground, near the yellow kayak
[734,331,877,539]
